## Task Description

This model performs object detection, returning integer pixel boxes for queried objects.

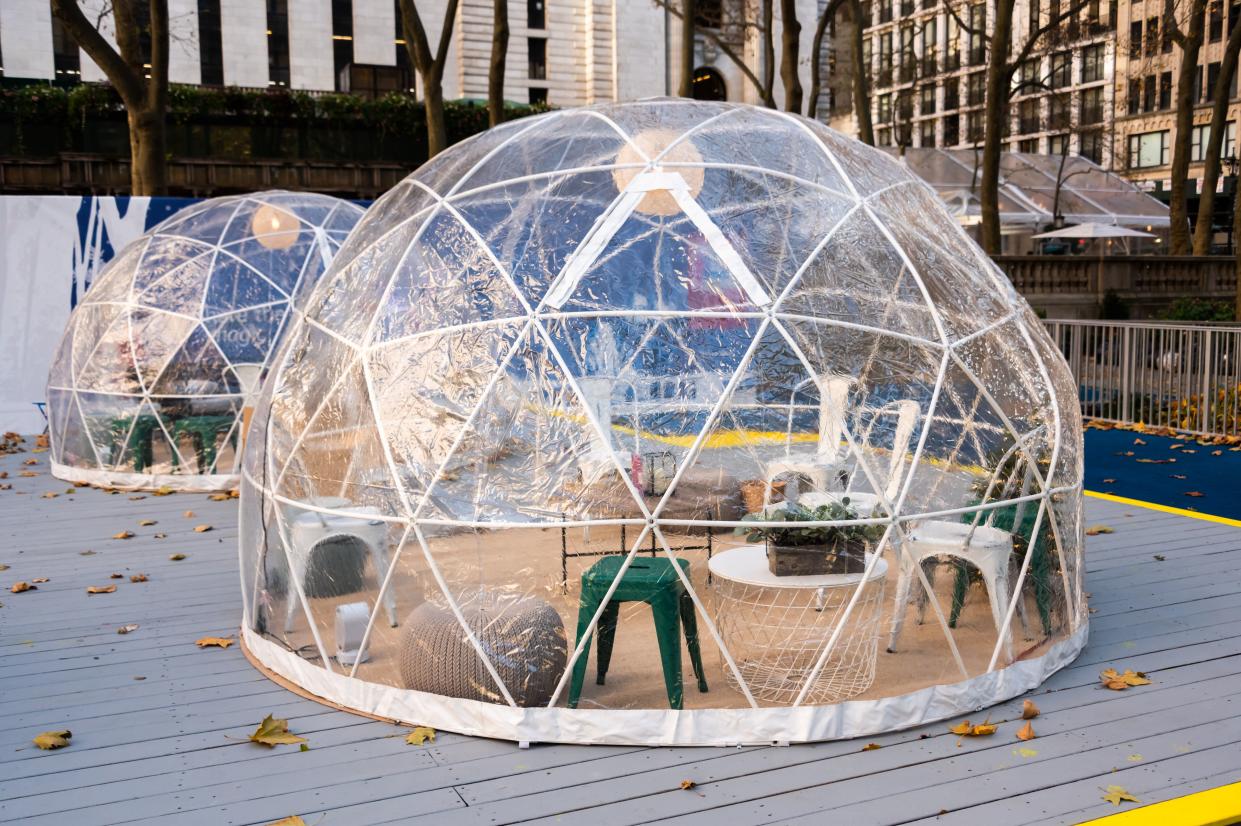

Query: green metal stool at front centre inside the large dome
[568,554,707,708]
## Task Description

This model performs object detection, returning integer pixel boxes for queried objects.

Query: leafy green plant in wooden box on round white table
[737,496,884,577]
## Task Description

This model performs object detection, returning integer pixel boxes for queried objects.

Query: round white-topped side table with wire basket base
[709,544,887,704]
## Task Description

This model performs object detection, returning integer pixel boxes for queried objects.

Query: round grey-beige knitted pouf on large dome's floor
[401,593,568,707]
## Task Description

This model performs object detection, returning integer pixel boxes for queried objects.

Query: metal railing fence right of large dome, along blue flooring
[1044,320,1241,437]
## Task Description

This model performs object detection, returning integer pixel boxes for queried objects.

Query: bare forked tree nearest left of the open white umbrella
[947,0,1087,255]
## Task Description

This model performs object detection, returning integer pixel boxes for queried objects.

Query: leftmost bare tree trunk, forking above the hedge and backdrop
[51,0,169,195]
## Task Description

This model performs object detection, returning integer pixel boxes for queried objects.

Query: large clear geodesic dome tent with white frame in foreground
[241,100,1087,744]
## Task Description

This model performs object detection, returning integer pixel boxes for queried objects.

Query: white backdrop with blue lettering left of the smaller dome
[0,195,196,433]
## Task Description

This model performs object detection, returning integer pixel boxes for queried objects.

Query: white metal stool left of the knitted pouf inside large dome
[284,496,397,633]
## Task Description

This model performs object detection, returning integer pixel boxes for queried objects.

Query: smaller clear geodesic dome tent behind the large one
[47,191,362,490]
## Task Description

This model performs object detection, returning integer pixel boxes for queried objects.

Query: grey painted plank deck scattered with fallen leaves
[0,444,1241,826]
